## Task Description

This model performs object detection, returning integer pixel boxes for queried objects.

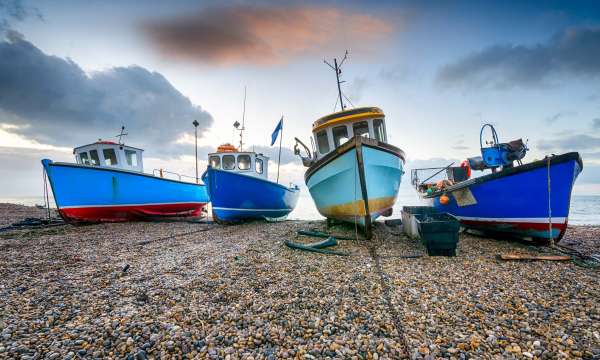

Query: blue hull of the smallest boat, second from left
[202,166,300,222]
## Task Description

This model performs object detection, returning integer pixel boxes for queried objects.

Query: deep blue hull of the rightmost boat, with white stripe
[426,153,583,240]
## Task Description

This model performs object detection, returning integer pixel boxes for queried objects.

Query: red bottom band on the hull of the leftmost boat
[59,203,206,222]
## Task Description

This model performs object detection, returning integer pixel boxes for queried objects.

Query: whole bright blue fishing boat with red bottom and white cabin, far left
[42,128,209,223]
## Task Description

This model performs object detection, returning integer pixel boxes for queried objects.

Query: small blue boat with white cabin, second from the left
[202,145,300,222]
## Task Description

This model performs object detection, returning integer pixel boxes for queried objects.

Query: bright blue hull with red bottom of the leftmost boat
[42,160,209,222]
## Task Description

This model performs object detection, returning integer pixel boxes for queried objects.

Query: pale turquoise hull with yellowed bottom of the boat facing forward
[305,137,404,238]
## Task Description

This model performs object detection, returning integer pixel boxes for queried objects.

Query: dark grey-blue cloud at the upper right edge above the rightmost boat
[437,27,600,89]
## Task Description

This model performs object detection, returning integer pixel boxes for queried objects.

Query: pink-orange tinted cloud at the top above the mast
[142,5,392,65]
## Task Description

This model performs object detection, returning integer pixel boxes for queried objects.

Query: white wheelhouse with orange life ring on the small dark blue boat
[208,144,269,179]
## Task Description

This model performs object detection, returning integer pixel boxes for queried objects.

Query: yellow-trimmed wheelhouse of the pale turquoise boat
[312,107,387,159]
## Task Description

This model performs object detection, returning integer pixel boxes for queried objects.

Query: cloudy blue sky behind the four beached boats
[0,0,600,198]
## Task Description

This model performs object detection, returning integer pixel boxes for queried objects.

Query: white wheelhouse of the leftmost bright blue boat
[73,141,144,172]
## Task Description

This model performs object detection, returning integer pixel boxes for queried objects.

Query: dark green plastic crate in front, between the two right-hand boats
[415,213,460,256]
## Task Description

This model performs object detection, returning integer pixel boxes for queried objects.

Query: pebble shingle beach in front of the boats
[0,204,600,359]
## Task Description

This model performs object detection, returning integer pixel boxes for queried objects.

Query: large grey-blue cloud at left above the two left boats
[0,32,213,154]
